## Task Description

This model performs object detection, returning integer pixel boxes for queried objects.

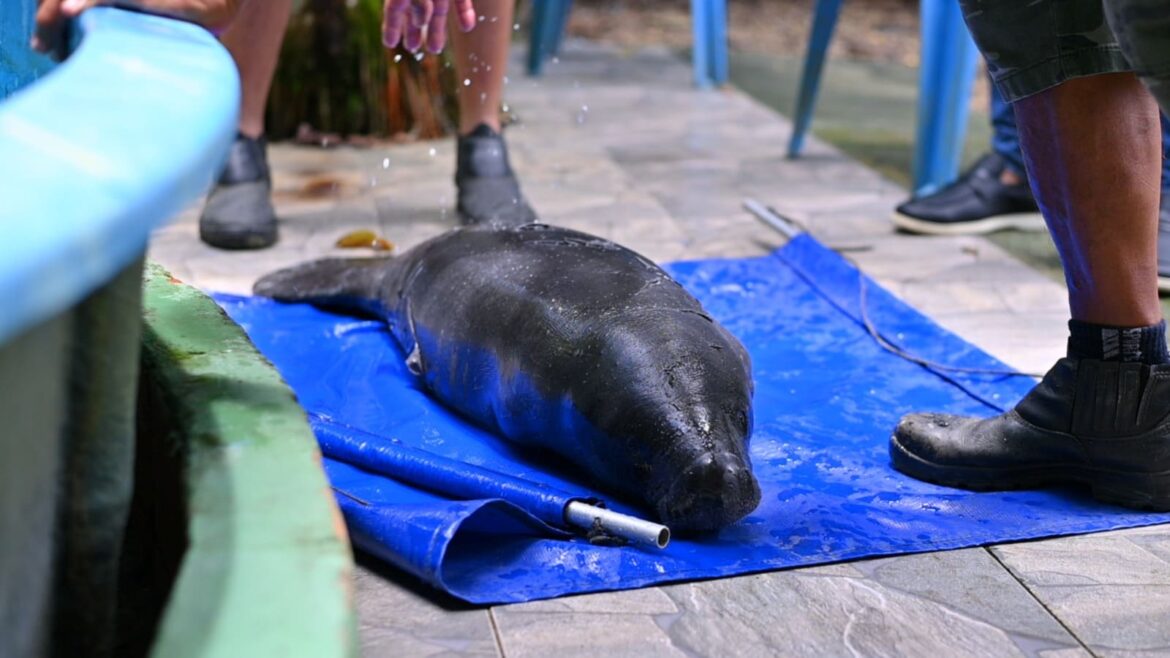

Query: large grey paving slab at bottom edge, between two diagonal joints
[493,549,1087,656]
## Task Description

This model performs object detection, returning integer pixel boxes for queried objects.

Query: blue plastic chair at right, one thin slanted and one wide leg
[789,0,979,196]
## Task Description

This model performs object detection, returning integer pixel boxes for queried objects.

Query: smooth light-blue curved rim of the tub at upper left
[0,7,240,341]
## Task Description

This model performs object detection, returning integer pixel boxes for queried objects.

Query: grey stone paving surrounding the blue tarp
[151,42,1170,658]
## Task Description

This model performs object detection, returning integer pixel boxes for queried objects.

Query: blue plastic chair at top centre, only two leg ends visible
[528,0,728,88]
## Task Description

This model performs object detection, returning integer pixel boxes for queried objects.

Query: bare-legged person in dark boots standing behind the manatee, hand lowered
[199,0,536,249]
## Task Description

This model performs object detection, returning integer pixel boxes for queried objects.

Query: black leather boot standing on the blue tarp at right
[889,358,1170,512]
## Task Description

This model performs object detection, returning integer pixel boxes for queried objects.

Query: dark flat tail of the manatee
[252,258,395,316]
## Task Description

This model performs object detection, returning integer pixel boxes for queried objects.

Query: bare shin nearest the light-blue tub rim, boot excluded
[221,0,293,138]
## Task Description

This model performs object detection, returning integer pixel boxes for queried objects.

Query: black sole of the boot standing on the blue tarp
[889,437,1170,512]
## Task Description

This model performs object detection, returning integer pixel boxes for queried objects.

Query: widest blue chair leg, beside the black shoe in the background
[914,0,979,196]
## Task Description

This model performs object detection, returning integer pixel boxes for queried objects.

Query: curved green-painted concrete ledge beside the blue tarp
[139,261,357,658]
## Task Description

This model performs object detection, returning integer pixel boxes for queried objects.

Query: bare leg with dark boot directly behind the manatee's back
[450,0,536,225]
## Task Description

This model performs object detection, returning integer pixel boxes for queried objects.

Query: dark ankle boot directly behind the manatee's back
[455,124,536,226]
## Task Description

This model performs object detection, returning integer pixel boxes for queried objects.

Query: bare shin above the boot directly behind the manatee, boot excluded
[450,0,516,135]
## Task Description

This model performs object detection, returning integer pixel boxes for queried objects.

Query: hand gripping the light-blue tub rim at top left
[30,0,242,56]
